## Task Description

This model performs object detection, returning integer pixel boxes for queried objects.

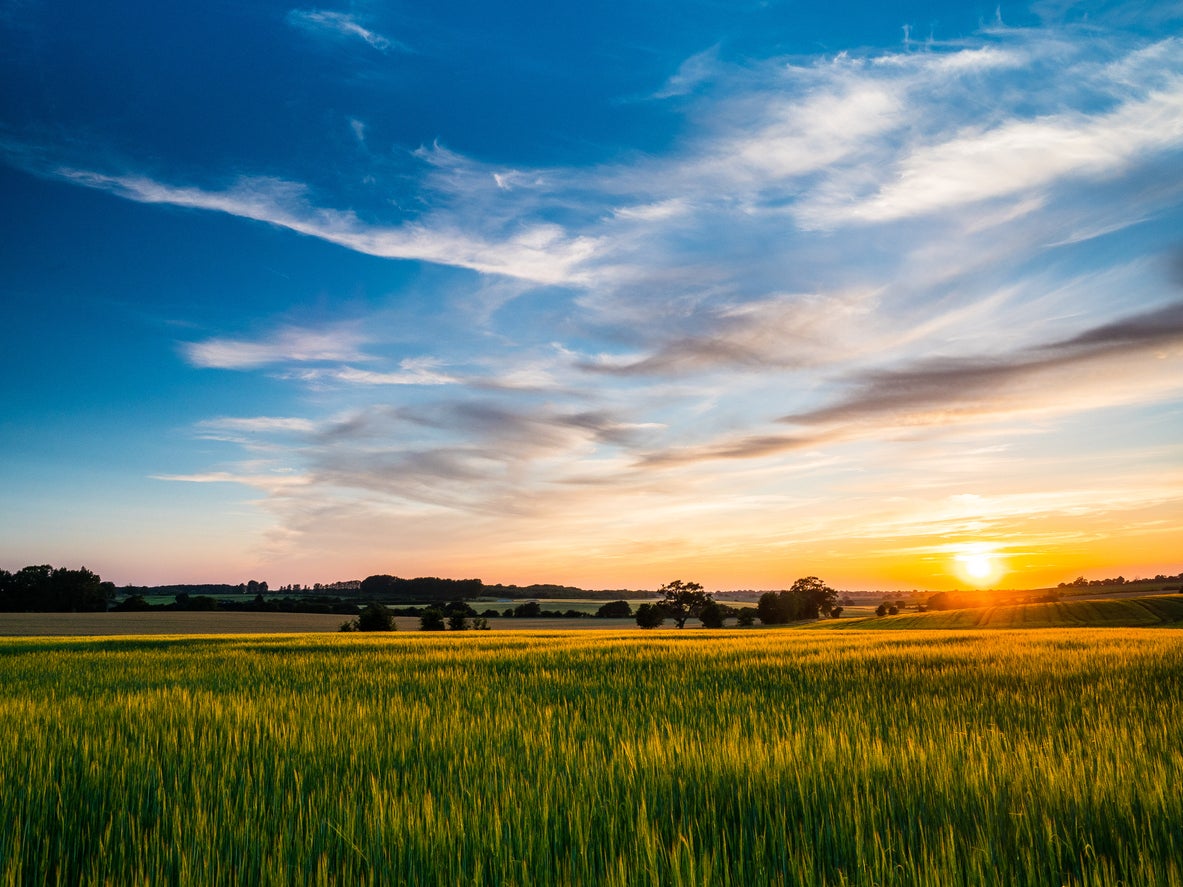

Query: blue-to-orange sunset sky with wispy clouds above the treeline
[0,0,1183,590]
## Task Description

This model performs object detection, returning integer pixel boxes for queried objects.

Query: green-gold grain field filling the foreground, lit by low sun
[0,617,1183,887]
